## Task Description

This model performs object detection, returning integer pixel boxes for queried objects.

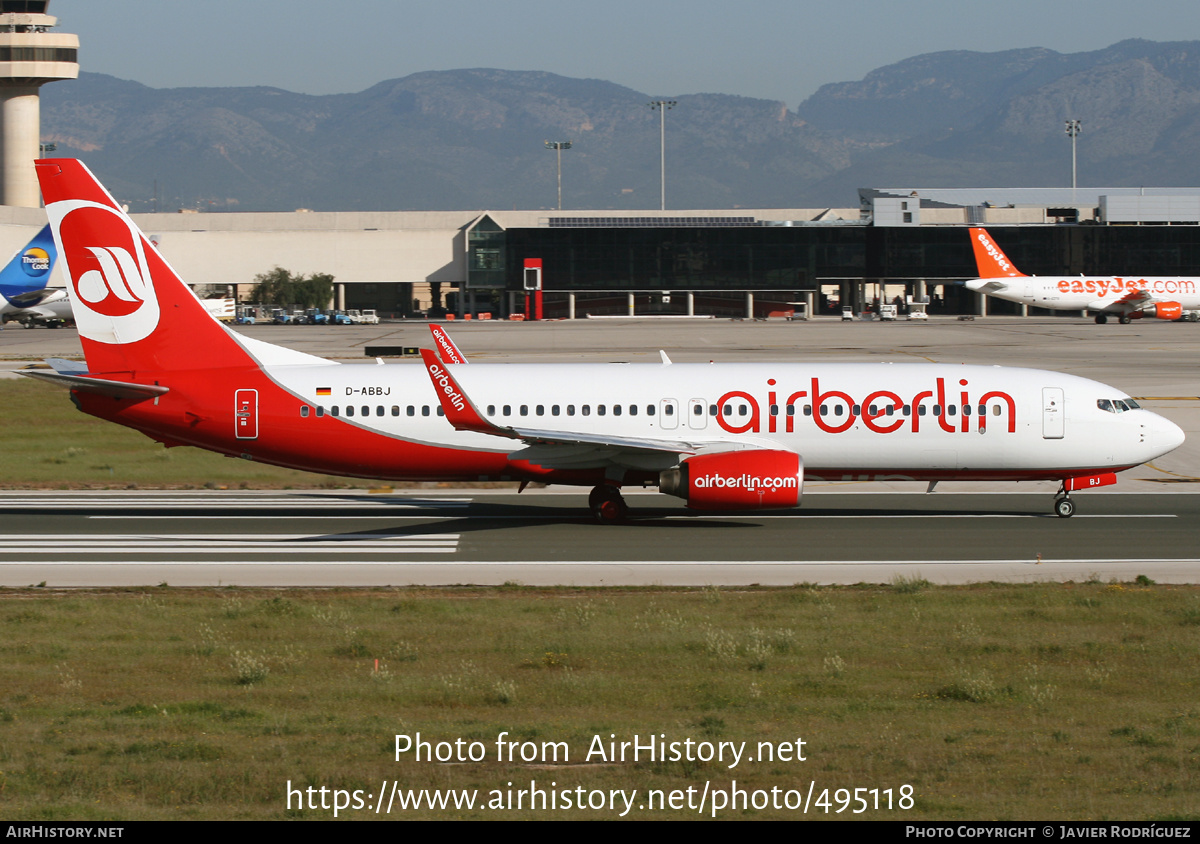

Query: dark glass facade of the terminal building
[451,215,1200,317]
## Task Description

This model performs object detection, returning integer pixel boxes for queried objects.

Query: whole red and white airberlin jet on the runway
[26,158,1183,520]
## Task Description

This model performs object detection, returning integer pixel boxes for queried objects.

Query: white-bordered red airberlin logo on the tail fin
[47,199,158,343]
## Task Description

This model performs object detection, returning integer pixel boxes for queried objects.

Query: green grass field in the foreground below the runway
[0,581,1200,820]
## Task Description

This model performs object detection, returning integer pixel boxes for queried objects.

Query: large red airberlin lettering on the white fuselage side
[716,377,1016,433]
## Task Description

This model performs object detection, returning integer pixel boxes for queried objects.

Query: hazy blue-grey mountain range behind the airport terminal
[42,40,1200,211]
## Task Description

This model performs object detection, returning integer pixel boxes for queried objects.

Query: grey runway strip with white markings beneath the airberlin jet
[0,490,1200,587]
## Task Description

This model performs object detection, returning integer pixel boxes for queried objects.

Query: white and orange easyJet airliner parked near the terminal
[966,228,1200,325]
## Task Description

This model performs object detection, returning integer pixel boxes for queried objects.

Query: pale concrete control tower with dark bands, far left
[0,0,79,208]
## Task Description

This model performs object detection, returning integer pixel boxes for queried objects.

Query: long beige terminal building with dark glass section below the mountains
[0,187,1200,318]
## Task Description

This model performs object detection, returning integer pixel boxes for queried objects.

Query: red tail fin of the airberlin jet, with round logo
[37,158,254,373]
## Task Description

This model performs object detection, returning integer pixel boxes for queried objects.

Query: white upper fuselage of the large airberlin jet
[258,364,1183,479]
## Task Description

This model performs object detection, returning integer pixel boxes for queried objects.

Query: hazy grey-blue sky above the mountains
[49,0,1200,107]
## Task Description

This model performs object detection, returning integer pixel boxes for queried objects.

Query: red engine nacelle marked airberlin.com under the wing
[659,449,804,510]
